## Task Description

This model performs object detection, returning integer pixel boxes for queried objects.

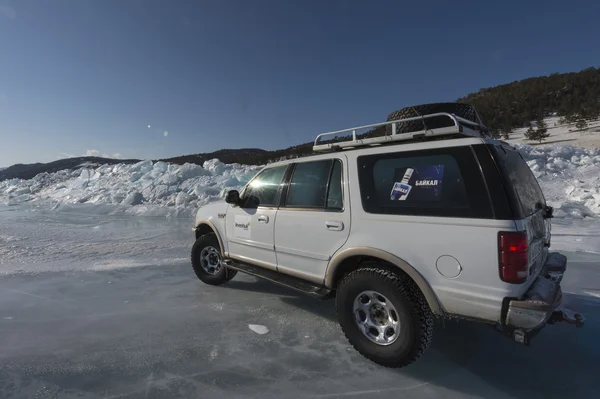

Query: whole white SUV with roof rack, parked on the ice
[192,104,583,367]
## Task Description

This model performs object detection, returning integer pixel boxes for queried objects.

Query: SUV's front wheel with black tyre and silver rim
[192,233,237,285]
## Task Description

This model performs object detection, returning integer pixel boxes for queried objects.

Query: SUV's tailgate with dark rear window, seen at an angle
[492,145,550,280]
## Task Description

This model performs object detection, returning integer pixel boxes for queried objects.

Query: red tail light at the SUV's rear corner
[498,231,529,284]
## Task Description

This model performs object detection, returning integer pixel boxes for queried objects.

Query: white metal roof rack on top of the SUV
[313,112,490,152]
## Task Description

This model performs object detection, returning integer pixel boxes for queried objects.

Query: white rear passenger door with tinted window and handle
[275,156,350,283]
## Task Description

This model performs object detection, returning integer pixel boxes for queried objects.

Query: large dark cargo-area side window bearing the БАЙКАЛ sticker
[358,147,493,218]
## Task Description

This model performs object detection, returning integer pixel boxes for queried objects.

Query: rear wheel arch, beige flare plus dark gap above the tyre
[325,247,444,315]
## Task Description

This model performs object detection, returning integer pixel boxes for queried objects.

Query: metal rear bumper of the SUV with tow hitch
[505,252,583,332]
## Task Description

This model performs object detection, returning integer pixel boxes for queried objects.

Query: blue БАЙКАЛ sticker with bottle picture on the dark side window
[390,165,444,202]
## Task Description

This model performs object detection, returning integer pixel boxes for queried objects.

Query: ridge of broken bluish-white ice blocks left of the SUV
[0,159,260,217]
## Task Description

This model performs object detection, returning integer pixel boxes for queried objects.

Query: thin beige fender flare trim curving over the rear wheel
[325,247,444,314]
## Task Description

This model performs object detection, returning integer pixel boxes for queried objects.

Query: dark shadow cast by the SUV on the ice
[280,288,600,399]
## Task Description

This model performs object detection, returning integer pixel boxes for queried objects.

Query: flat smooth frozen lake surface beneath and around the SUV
[0,207,600,399]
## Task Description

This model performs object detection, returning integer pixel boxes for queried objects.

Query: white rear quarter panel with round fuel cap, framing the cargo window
[343,139,526,321]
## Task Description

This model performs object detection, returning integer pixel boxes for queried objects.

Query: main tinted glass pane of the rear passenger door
[286,160,331,208]
